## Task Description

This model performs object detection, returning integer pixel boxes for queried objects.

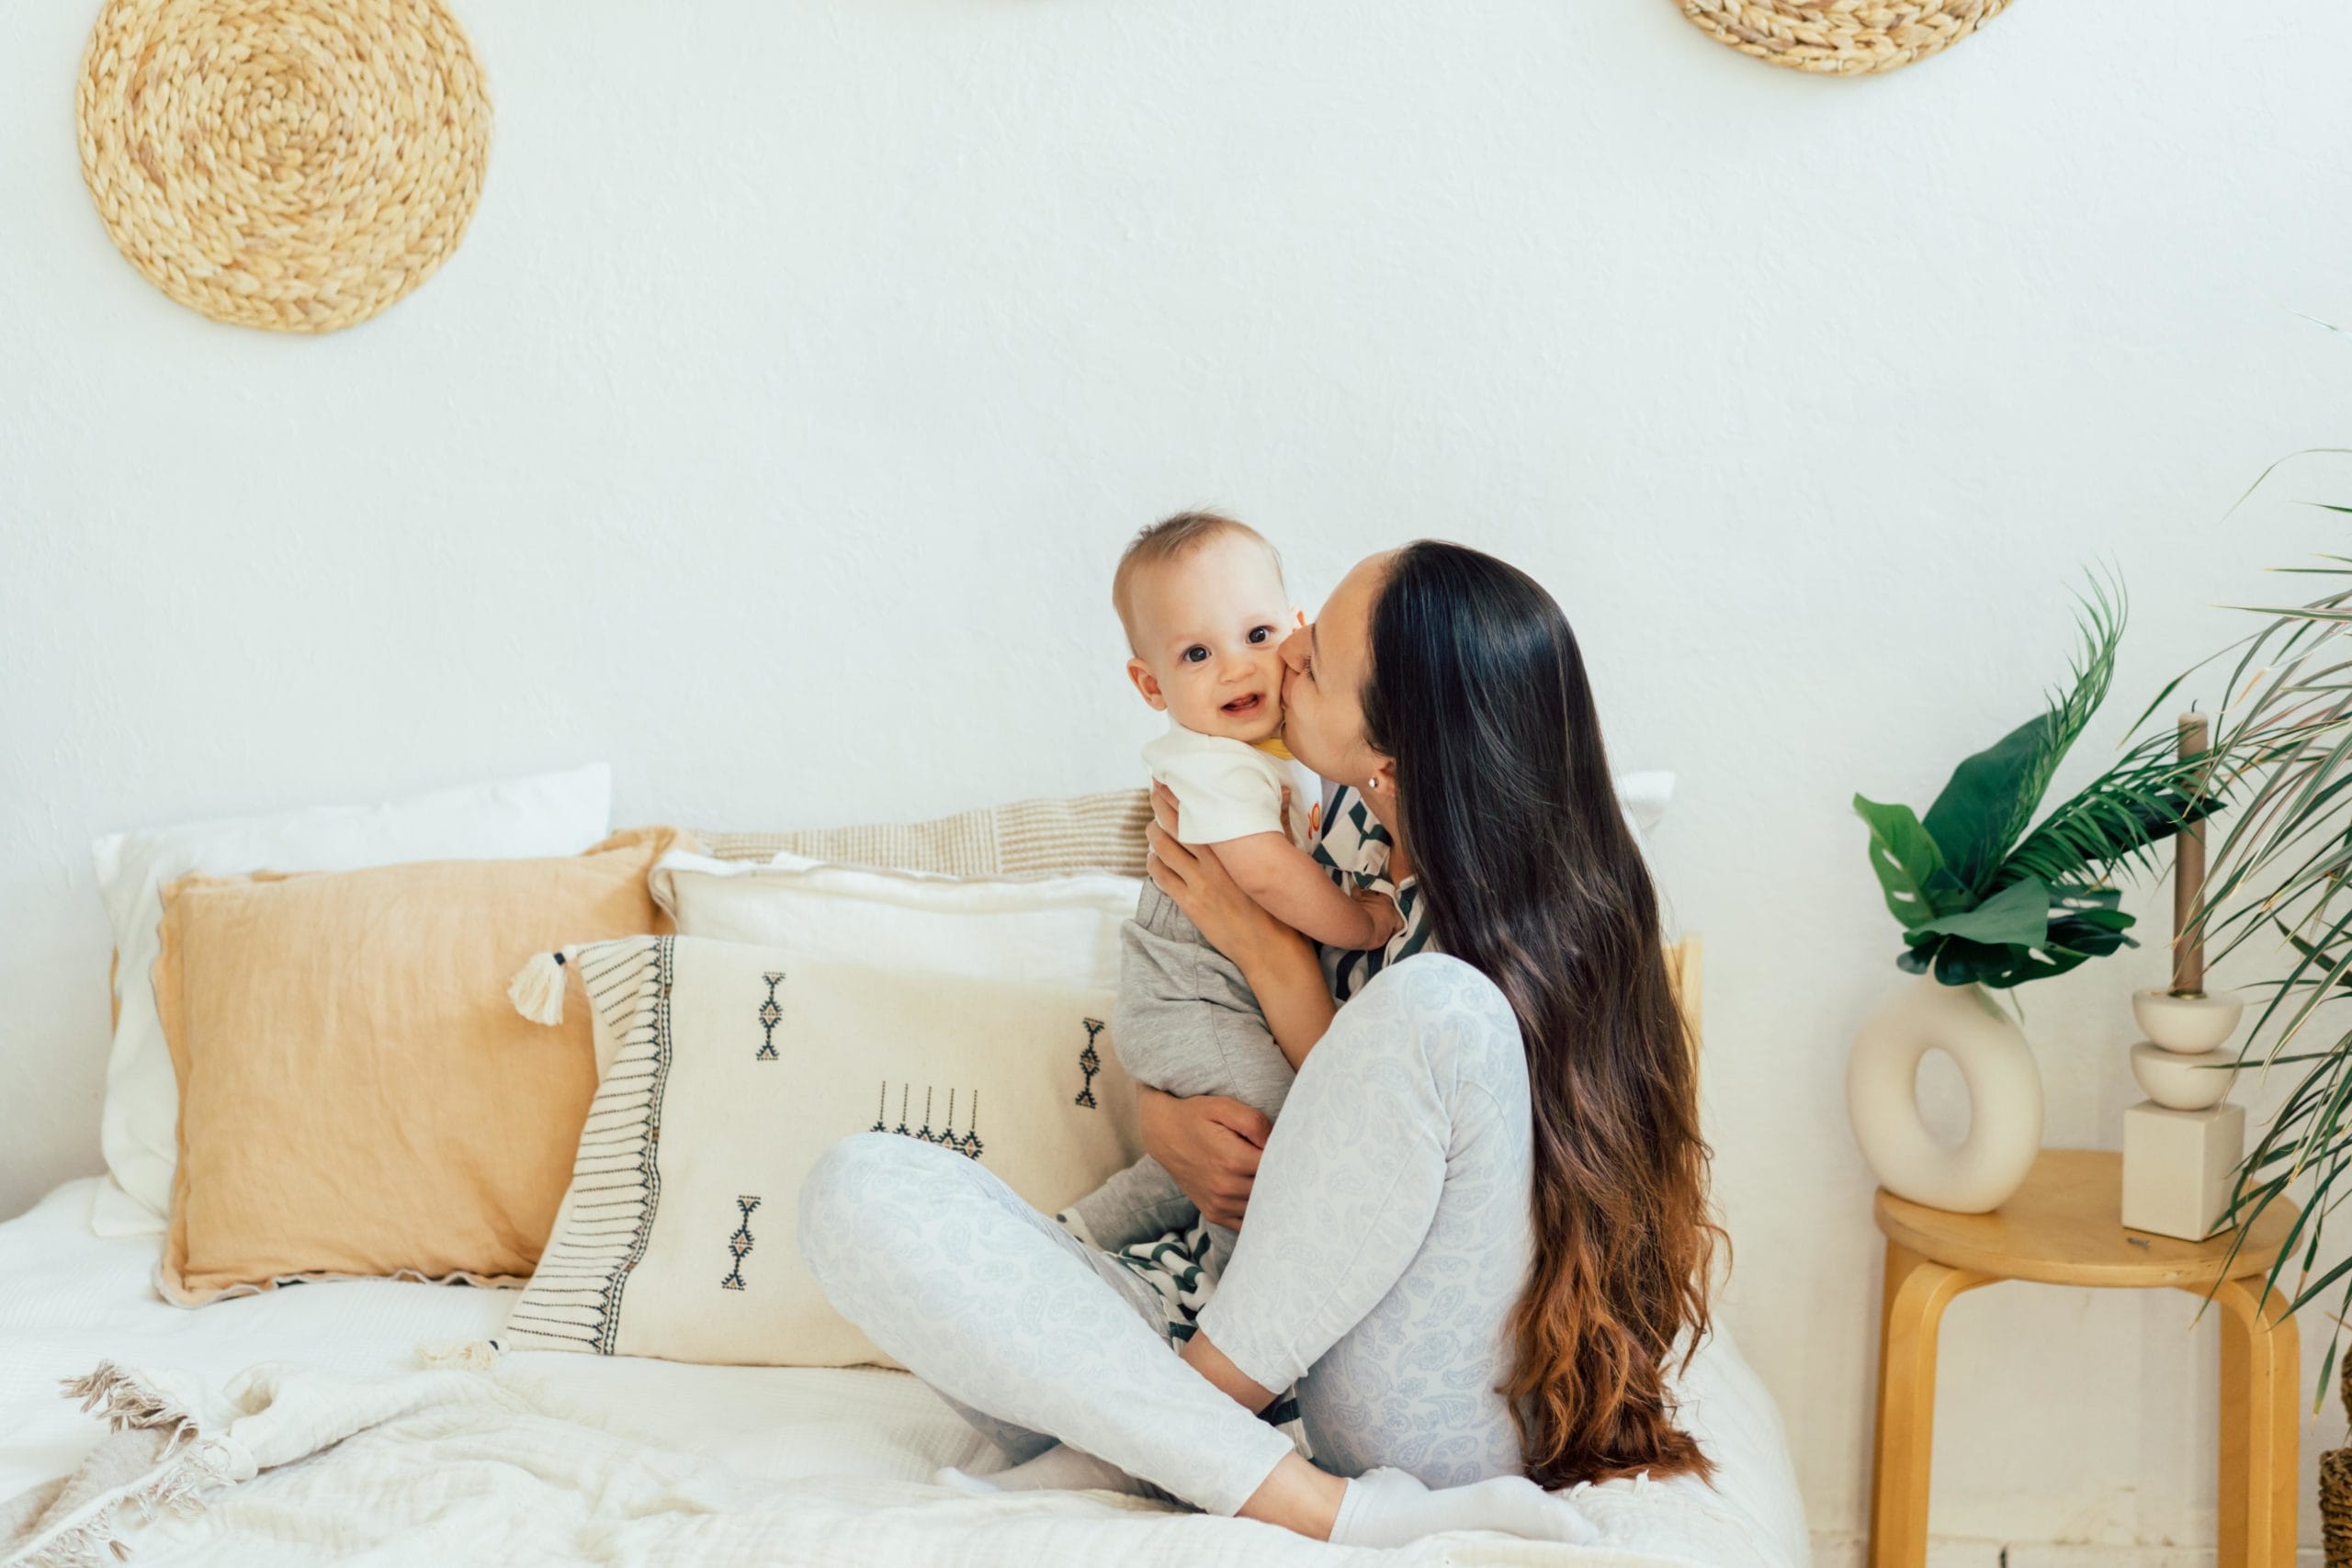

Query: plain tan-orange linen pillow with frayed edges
[155,828,680,1307]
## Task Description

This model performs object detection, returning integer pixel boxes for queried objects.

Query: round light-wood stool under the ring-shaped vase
[1870,1149,2301,1568]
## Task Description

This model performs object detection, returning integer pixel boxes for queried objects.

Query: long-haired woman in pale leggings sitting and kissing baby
[799,541,1719,1544]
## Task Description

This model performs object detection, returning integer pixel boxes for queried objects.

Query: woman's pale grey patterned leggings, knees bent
[799,952,1533,1514]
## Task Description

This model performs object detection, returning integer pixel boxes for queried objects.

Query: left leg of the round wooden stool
[1870,1241,1992,1568]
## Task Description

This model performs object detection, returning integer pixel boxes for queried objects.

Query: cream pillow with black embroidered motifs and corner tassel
[499,936,1141,1366]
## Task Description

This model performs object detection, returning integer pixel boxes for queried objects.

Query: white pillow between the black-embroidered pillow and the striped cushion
[651,851,1143,989]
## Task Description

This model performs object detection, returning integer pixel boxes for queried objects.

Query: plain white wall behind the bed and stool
[0,0,2352,1544]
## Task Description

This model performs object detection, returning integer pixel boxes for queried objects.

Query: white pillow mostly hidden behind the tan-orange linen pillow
[89,761,612,1236]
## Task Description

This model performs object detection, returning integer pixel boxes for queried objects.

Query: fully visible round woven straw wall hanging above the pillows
[73,0,489,332]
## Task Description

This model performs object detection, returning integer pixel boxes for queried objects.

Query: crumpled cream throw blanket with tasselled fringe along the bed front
[0,1352,1771,1568]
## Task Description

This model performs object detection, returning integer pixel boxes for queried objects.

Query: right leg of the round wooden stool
[2199,1274,2302,1568]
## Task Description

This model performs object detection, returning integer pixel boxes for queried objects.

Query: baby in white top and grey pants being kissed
[1058,513,1402,1274]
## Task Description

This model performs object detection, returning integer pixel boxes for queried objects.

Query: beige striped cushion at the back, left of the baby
[696,790,1152,877]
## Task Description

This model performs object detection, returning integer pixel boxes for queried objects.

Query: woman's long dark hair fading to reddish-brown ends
[1362,541,1729,1488]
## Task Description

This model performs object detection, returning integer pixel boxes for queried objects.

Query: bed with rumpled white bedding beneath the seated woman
[0,1180,1806,1568]
